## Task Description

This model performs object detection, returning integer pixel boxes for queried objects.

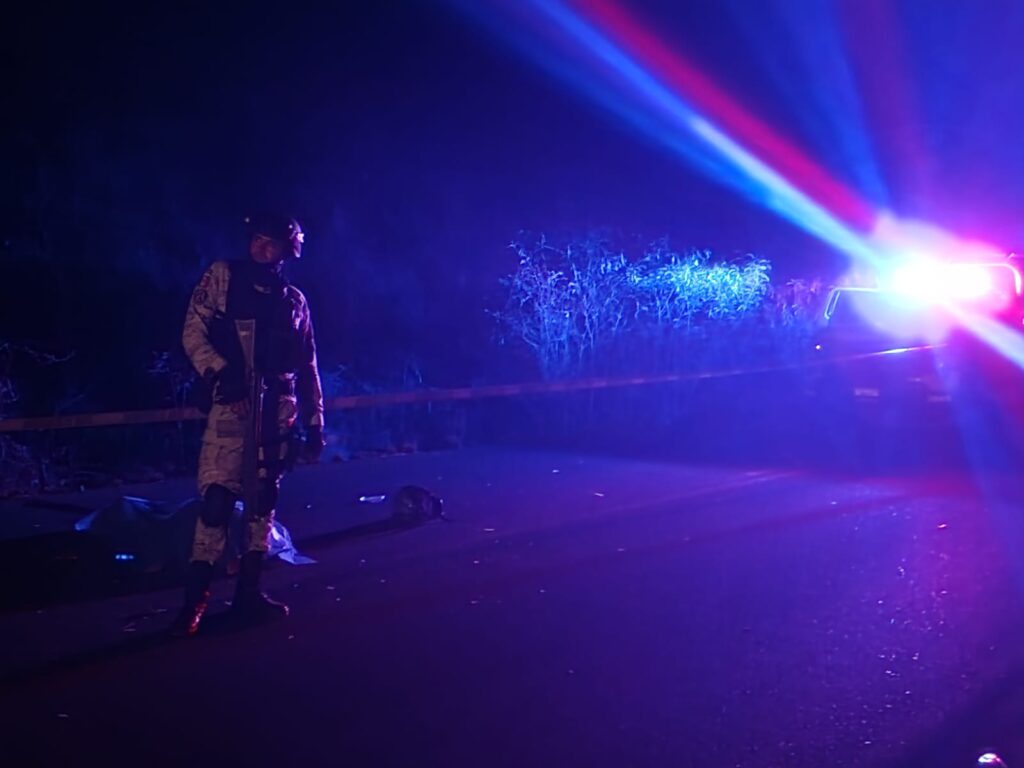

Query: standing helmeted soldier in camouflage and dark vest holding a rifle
[172,216,324,635]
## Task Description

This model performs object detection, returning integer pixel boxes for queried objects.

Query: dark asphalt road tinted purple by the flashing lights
[0,450,1024,768]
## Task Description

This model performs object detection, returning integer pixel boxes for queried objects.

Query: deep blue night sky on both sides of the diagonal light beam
[6,0,1024,415]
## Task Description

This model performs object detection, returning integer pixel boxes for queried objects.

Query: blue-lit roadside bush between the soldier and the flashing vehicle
[492,236,821,379]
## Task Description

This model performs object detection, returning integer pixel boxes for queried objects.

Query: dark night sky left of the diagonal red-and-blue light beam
[0,0,837,415]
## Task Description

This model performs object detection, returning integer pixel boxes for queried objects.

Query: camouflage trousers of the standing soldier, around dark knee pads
[191,395,298,563]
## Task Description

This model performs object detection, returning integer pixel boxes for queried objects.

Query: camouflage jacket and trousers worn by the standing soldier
[181,261,324,563]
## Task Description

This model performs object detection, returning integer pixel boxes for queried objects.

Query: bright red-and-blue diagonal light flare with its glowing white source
[451,0,1024,366]
